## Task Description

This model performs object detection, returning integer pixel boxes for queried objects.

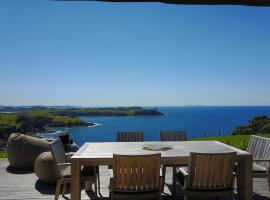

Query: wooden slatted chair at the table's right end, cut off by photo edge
[247,135,270,190]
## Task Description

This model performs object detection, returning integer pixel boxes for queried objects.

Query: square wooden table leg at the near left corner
[71,160,81,200]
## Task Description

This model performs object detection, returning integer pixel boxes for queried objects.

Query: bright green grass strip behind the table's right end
[191,134,270,150]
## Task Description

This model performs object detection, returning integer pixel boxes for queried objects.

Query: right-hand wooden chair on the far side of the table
[160,131,187,196]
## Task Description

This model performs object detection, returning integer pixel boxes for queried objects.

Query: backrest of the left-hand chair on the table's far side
[117,131,144,142]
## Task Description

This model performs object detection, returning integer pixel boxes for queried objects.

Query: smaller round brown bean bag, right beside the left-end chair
[35,151,57,184]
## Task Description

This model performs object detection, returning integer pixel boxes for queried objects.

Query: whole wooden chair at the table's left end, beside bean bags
[49,139,98,200]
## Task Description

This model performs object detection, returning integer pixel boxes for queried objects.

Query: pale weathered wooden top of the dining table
[71,141,250,164]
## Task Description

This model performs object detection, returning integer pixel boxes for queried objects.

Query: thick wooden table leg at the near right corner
[237,155,253,200]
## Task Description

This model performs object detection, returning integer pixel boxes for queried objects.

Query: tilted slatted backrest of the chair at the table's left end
[49,139,66,164]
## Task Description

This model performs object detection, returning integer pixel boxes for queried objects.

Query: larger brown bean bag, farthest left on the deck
[7,133,49,169]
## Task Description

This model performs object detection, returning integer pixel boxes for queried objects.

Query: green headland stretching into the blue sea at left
[0,106,164,139]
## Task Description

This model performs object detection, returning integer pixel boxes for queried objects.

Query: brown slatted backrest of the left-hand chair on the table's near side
[113,154,161,192]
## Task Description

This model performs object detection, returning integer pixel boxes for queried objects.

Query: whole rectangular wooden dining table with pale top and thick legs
[71,141,253,200]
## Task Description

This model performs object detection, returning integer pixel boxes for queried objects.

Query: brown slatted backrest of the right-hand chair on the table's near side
[186,152,236,190]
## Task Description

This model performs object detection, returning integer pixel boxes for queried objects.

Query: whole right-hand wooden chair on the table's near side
[178,152,236,200]
